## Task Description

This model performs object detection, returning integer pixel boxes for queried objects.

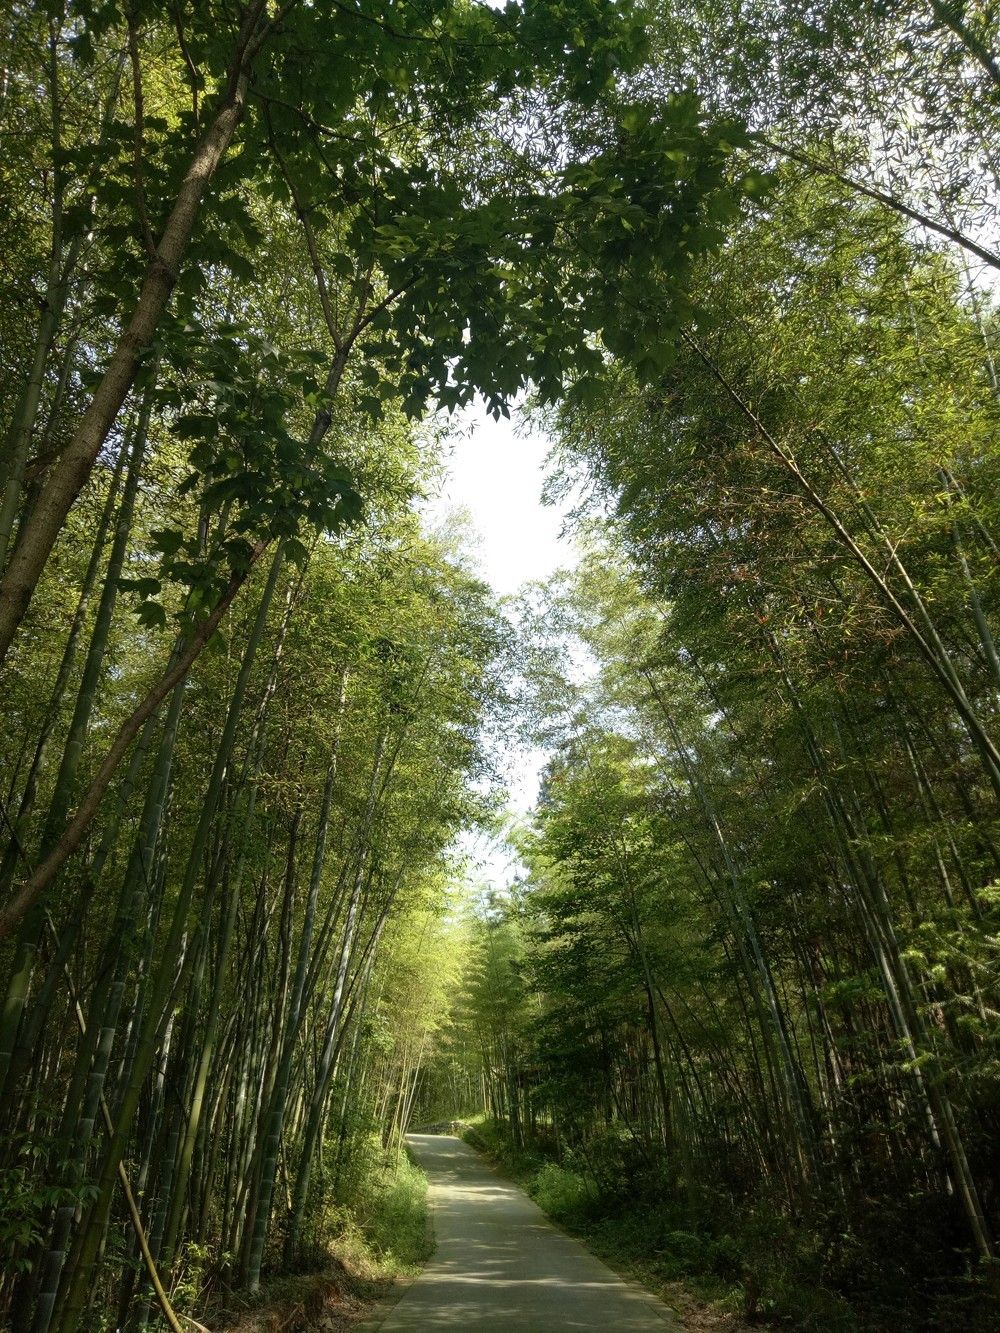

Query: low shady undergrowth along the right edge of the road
[464,1120,1000,1333]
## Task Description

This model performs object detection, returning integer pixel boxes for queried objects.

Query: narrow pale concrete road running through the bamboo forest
[379,1134,677,1333]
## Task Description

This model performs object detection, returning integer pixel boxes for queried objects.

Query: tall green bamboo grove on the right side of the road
[424,91,1000,1329]
